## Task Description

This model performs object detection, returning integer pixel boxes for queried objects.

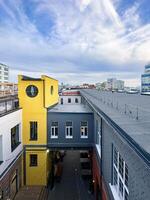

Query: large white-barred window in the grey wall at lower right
[113,148,129,200]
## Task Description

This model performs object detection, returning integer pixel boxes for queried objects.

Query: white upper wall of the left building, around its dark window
[0,109,22,180]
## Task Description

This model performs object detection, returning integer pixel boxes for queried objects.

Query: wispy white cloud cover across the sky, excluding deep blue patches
[0,0,150,85]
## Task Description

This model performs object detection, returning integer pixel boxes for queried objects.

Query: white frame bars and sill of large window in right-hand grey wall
[110,147,129,200]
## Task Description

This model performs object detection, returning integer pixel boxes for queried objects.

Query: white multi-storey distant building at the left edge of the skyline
[0,63,9,83]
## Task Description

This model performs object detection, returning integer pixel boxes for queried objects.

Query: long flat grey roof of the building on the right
[81,89,150,154]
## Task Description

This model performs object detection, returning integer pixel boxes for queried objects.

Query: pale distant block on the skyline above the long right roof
[106,78,124,91]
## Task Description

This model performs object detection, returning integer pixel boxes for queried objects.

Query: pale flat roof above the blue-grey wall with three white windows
[48,104,92,113]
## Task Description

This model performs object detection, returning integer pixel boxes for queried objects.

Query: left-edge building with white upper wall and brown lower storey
[0,96,22,199]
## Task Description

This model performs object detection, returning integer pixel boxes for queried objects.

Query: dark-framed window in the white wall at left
[11,124,20,151]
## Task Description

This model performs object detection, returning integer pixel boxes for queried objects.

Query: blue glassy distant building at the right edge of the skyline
[141,64,150,94]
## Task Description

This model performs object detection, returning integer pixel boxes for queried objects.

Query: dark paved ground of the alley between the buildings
[49,151,93,200]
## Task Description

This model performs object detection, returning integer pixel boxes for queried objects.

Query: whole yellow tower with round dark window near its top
[18,75,58,185]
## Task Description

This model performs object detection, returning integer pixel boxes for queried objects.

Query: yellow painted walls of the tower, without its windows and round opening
[18,75,58,185]
